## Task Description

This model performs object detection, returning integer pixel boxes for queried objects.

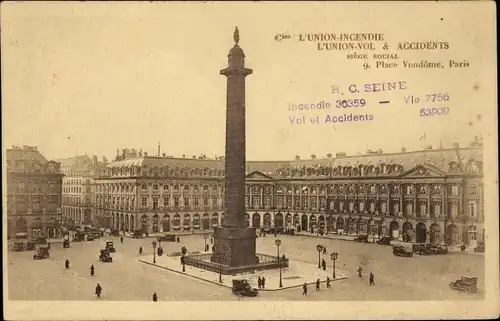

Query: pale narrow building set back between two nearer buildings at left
[57,155,105,225]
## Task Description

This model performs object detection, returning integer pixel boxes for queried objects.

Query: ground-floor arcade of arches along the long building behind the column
[93,211,484,247]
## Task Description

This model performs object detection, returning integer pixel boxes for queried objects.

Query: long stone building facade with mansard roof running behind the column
[96,139,484,246]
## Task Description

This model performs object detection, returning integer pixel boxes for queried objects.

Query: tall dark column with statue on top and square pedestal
[211,27,258,267]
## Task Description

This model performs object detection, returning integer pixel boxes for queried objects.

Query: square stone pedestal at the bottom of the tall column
[210,227,259,267]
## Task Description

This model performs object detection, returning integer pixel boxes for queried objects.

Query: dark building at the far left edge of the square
[7,146,63,239]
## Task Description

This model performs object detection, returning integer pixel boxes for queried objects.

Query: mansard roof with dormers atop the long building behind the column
[97,147,482,178]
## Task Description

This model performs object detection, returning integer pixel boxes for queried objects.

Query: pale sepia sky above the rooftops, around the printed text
[1,2,496,160]
